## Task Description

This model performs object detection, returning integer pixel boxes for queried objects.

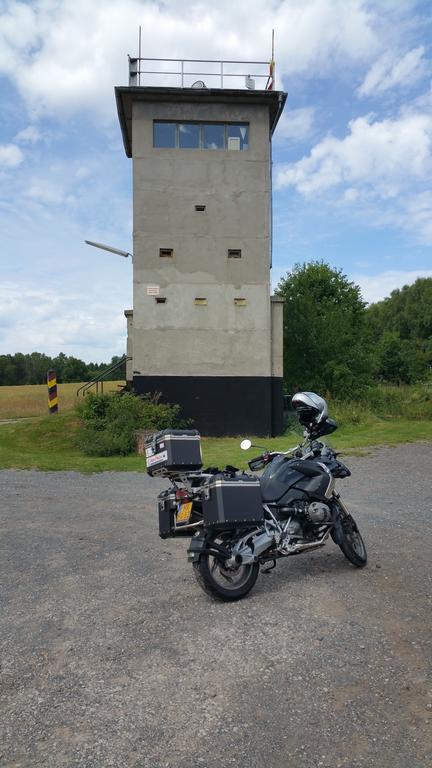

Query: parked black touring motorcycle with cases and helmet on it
[146,392,367,601]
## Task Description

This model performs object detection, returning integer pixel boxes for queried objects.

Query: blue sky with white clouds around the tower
[0,0,432,361]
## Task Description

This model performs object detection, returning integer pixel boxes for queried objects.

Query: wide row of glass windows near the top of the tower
[153,120,249,150]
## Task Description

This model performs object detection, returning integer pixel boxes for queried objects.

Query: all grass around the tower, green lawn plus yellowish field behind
[0,382,432,472]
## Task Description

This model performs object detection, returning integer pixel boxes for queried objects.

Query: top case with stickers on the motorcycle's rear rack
[146,429,202,477]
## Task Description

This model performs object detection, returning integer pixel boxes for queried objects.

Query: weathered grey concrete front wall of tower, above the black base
[132,97,272,376]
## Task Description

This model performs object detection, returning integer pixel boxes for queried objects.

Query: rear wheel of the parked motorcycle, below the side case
[192,535,259,602]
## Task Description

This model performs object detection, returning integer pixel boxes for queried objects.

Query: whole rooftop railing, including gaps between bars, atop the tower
[128,56,275,90]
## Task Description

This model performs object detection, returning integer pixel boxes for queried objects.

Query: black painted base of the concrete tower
[133,376,283,437]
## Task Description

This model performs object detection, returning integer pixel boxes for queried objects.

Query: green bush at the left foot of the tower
[77,392,184,456]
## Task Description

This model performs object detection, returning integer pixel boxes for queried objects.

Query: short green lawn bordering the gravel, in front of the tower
[0,412,432,472]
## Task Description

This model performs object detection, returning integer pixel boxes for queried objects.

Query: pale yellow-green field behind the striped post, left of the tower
[0,381,124,420]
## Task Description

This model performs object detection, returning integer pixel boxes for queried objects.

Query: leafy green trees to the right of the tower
[276,261,432,398]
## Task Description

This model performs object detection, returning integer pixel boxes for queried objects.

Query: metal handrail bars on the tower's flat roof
[128,56,275,88]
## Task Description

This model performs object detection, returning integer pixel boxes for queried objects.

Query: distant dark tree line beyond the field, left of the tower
[0,352,125,385]
